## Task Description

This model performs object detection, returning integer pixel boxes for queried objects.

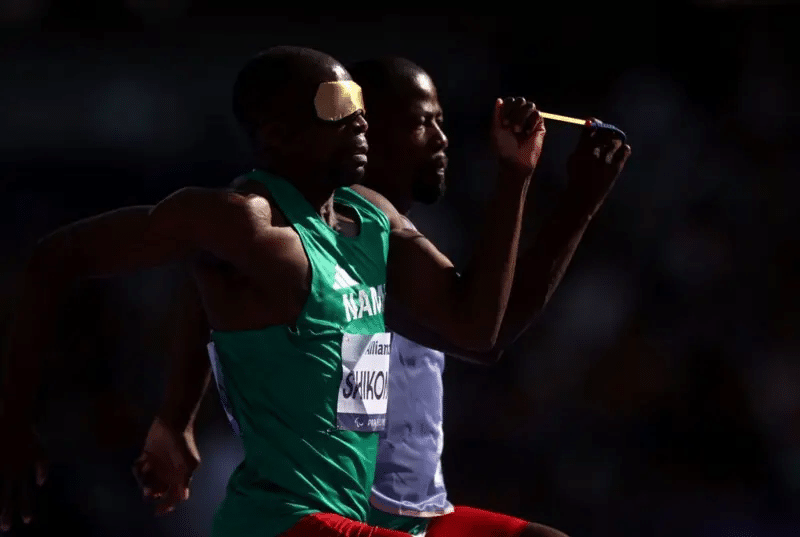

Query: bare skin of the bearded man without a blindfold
[135,60,630,536]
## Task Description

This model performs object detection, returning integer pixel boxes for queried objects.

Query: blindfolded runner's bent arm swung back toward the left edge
[0,188,264,529]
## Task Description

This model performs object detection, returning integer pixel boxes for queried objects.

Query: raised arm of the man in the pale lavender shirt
[387,124,631,363]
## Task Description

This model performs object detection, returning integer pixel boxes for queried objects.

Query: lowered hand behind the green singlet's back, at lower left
[133,418,200,515]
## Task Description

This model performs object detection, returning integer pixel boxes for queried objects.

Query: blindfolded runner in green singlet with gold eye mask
[0,47,544,537]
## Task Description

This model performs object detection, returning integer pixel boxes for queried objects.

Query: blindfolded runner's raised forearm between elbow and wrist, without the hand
[453,167,530,351]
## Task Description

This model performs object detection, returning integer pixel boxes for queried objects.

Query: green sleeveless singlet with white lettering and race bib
[212,170,390,537]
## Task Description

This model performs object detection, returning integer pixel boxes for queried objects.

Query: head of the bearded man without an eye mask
[349,57,447,209]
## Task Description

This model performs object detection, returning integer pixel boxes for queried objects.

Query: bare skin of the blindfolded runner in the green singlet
[0,47,544,529]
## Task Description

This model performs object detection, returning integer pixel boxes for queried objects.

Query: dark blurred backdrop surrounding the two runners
[0,0,800,537]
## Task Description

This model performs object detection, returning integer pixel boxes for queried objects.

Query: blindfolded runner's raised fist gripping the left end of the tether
[492,97,545,175]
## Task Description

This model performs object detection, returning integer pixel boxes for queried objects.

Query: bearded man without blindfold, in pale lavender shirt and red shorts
[131,58,630,537]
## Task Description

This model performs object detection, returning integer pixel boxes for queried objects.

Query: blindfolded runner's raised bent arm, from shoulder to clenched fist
[368,98,545,352]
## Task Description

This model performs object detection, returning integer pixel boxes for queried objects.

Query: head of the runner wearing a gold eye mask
[233,47,367,186]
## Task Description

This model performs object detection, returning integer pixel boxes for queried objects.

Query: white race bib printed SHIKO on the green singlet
[336,332,392,432]
